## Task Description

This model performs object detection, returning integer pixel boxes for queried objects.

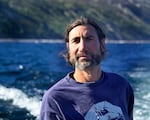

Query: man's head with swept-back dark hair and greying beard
[62,17,105,70]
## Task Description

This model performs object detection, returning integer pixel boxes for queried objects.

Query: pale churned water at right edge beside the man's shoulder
[129,68,150,120]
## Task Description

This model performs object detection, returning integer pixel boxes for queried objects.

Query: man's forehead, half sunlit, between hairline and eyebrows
[69,25,97,37]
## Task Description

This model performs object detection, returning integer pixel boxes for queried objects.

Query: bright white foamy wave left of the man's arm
[0,85,41,119]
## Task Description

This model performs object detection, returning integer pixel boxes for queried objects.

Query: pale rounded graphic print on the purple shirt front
[85,101,125,120]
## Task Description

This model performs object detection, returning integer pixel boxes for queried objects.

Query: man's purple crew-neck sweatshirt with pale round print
[40,72,134,120]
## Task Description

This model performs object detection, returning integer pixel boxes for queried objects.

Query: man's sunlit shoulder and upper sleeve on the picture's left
[40,76,68,120]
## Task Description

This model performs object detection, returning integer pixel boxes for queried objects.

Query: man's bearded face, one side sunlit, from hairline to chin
[67,25,104,70]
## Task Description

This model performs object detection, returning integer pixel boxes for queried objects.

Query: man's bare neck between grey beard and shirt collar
[73,67,102,83]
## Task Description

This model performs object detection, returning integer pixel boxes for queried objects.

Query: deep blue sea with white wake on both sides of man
[0,40,150,120]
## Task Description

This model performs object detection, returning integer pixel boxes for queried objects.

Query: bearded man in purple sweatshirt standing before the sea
[40,17,134,120]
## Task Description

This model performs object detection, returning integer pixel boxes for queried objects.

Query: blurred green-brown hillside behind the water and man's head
[0,0,150,41]
